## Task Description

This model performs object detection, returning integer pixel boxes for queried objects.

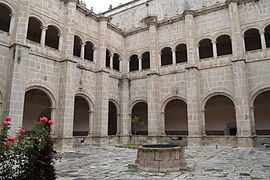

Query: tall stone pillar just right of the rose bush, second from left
[55,0,77,150]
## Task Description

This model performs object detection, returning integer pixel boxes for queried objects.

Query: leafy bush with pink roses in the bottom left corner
[0,117,57,180]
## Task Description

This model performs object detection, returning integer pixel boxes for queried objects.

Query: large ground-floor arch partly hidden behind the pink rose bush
[22,85,57,133]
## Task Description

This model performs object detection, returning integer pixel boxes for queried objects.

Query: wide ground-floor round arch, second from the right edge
[202,92,237,135]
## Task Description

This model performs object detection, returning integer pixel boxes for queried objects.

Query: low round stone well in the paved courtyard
[135,144,186,172]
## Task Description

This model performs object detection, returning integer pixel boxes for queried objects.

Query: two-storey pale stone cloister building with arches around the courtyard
[0,0,270,149]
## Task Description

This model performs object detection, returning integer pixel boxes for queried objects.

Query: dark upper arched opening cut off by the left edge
[0,3,11,32]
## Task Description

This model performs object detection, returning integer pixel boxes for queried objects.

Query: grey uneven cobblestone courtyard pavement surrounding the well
[56,147,270,180]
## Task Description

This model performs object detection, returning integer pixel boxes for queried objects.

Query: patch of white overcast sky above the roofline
[84,0,131,13]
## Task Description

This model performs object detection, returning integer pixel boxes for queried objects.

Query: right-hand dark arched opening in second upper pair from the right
[217,35,232,56]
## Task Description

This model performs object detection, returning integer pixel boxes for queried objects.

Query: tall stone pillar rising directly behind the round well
[147,22,163,136]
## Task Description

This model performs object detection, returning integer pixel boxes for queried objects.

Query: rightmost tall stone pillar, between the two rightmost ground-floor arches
[228,1,253,146]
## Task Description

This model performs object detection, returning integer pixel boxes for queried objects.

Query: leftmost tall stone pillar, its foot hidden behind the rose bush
[2,0,30,135]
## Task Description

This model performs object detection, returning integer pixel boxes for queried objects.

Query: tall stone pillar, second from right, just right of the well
[184,10,203,146]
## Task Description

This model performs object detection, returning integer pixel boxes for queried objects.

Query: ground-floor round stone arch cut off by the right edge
[250,85,270,135]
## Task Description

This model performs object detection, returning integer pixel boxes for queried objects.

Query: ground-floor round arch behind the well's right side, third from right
[161,95,188,136]
